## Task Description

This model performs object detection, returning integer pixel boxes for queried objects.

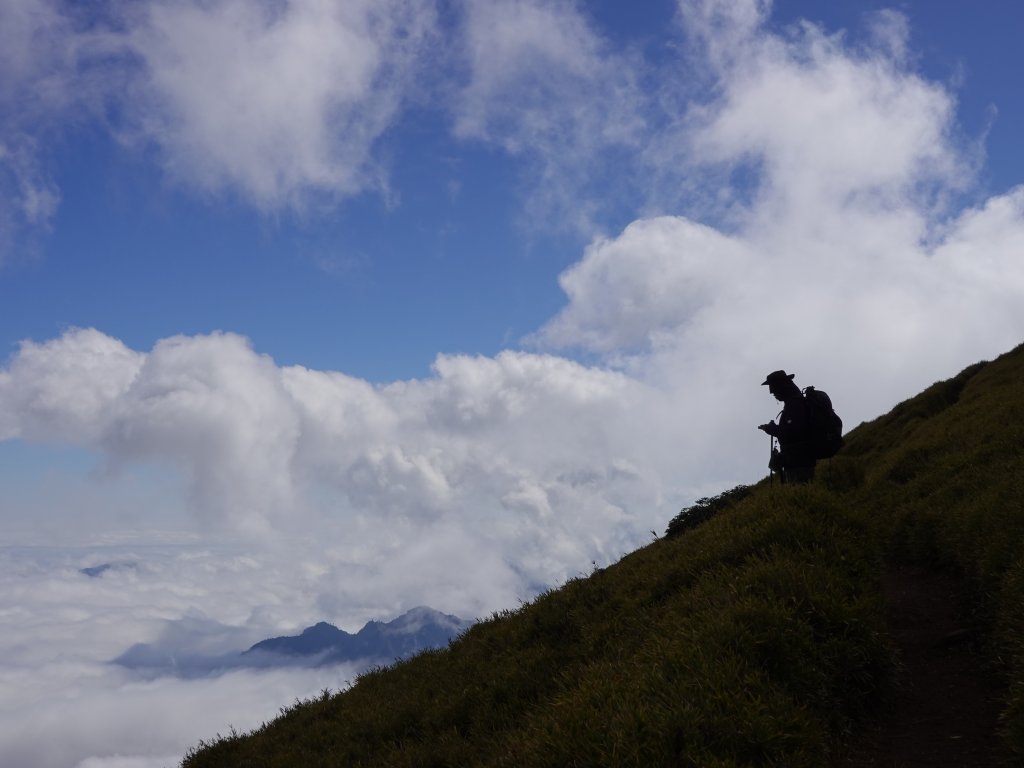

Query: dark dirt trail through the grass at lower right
[835,566,1010,768]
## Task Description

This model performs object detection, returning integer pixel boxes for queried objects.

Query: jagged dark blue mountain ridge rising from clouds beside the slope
[243,606,473,666]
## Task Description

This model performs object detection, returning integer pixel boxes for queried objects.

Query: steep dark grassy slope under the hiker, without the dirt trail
[183,347,1024,768]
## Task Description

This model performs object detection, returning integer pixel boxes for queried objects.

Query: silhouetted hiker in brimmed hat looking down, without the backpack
[758,371,817,483]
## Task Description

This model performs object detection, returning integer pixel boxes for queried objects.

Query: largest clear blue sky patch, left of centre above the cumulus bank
[2,91,561,381]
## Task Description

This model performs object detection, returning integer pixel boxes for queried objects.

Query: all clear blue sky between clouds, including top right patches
[0,2,1024,382]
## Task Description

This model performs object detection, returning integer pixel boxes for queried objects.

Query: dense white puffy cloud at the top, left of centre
[120,0,434,210]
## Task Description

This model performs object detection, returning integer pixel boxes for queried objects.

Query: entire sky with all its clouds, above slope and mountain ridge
[0,0,1024,768]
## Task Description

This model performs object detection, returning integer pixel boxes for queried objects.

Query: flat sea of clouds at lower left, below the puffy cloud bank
[0,537,364,768]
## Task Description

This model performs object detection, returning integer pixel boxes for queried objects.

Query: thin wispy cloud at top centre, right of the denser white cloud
[451,0,654,232]
